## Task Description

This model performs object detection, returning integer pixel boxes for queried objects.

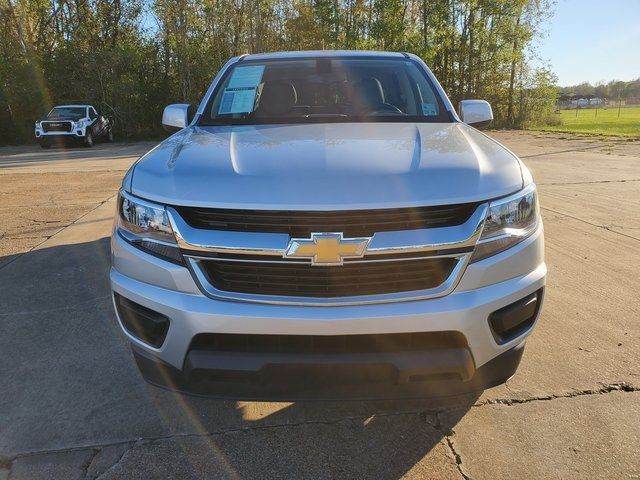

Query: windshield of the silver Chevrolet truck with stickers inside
[199,58,452,125]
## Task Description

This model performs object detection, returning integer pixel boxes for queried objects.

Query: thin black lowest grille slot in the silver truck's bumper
[190,332,467,354]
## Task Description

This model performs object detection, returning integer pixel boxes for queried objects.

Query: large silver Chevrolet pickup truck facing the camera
[110,51,546,399]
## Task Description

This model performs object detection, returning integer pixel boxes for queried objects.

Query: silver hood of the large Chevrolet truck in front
[125,123,523,210]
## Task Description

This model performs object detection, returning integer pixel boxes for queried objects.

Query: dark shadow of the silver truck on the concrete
[0,238,479,479]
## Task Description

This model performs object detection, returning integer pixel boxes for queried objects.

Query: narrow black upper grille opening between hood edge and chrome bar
[175,203,479,237]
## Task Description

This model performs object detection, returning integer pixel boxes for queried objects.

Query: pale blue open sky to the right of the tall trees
[538,0,640,86]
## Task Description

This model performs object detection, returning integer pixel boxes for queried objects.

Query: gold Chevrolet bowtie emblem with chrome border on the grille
[284,233,371,265]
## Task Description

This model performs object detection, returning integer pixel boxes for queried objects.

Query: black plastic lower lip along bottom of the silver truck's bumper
[132,342,525,401]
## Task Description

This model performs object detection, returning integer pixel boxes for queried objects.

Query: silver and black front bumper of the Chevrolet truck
[111,228,546,398]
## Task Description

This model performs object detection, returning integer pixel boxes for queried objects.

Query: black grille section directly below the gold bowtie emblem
[200,258,457,297]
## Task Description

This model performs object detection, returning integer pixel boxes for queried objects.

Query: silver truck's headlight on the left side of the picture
[116,191,184,265]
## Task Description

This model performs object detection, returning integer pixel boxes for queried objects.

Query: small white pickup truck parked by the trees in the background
[35,105,113,148]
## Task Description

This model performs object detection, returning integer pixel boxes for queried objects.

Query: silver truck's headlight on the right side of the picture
[472,184,540,261]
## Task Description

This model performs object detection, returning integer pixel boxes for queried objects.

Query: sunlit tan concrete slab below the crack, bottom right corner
[444,391,640,479]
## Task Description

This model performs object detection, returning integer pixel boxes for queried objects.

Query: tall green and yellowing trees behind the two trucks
[0,0,556,143]
